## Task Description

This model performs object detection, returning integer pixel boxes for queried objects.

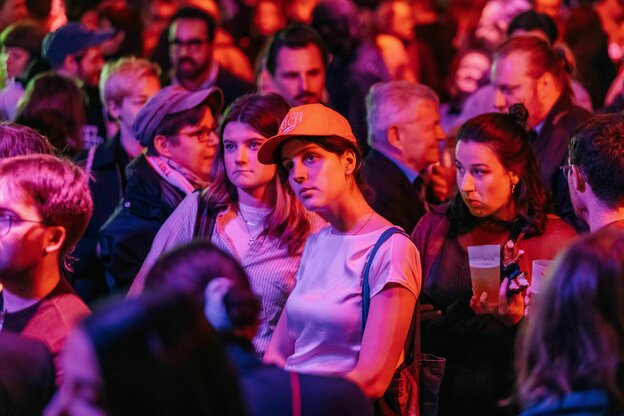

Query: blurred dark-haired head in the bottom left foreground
[45,293,244,416]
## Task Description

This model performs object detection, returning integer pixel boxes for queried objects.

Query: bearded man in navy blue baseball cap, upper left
[41,22,114,147]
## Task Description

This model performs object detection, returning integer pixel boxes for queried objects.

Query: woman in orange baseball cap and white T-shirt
[258,104,421,398]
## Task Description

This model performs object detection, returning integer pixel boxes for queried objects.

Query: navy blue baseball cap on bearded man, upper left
[41,22,115,68]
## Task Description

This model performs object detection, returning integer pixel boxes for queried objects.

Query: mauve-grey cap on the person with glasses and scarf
[132,85,223,146]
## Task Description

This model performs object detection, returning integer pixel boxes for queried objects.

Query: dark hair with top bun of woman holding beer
[446,104,547,236]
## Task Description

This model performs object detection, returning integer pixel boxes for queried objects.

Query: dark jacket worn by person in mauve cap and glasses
[99,155,185,293]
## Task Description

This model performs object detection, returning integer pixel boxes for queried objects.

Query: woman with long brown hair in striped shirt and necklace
[129,94,319,354]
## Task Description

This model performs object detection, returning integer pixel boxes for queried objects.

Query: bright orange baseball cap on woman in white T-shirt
[258,104,357,165]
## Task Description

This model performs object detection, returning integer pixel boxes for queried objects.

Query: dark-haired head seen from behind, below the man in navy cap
[15,72,87,157]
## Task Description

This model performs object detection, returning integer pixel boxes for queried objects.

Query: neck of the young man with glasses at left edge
[2,263,61,313]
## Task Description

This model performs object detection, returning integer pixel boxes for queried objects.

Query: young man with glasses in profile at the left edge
[0,155,93,381]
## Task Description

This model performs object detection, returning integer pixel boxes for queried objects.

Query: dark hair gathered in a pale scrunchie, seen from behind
[145,240,260,329]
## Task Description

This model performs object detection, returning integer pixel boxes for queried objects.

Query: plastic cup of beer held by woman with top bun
[468,244,500,308]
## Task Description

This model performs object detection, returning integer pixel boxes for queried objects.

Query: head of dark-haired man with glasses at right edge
[561,114,624,232]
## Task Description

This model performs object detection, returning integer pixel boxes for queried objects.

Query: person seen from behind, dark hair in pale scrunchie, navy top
[147,241,372,416]
